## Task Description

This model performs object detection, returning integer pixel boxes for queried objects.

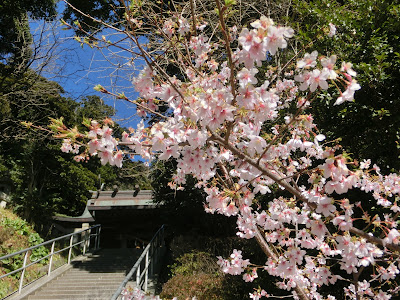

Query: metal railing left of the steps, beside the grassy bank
[0,225,101,297]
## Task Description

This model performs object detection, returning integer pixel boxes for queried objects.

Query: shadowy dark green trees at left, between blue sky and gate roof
[0,65,149,223]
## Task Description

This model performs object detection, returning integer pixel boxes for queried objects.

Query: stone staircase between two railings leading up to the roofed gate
[22,249,142,300]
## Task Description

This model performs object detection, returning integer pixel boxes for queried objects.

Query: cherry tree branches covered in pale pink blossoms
[50,0,400,299]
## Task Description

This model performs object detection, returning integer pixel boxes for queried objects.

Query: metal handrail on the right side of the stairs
[111,225,164,300]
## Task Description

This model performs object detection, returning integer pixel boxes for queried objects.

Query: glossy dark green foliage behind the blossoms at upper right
[292,0,400,172]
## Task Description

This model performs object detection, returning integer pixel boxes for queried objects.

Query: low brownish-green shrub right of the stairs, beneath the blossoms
[161,234,285,300]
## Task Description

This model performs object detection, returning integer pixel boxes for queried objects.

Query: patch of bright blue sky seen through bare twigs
[31,9,143,127]
